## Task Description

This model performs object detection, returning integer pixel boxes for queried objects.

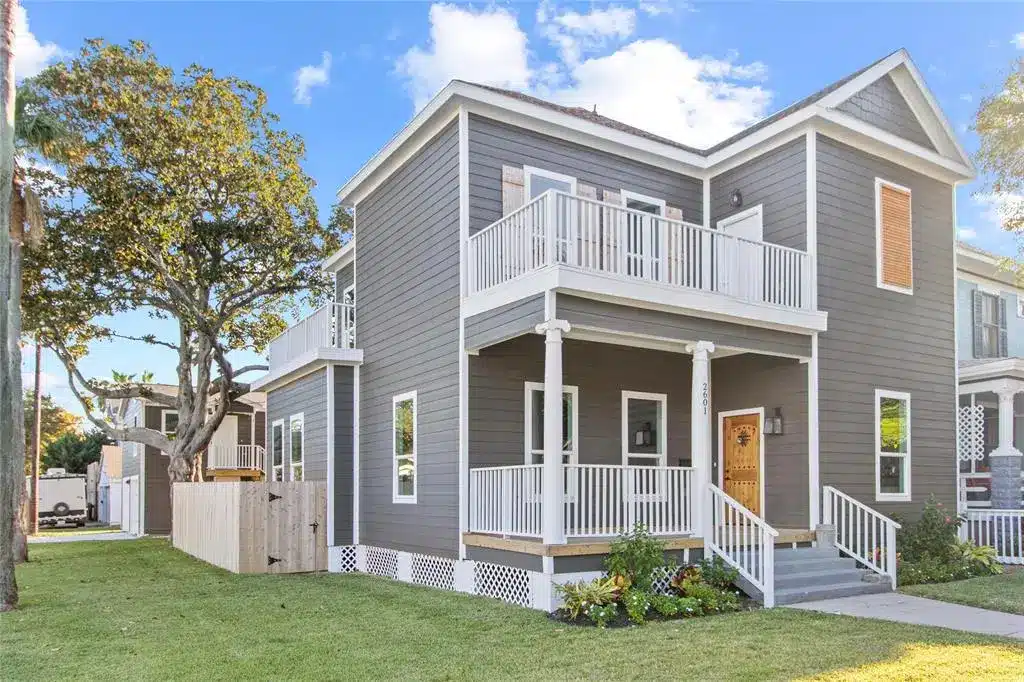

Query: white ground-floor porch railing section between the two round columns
[564,464,693,538]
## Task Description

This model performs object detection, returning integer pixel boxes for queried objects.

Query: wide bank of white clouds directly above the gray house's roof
[396,4,772,146]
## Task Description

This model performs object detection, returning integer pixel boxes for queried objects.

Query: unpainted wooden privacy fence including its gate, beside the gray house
[171,481,327,573]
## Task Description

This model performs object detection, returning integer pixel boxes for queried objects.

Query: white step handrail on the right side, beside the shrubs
[821,485,901,590]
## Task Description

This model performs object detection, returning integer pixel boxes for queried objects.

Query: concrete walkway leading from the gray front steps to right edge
[786,592,1024,639]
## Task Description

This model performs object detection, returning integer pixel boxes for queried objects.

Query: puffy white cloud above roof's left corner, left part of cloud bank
[395,4,532,110]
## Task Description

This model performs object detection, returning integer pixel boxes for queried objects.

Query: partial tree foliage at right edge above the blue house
[974,58,1024,279]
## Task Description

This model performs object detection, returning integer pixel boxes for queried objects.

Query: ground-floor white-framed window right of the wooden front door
[874,389,910,502]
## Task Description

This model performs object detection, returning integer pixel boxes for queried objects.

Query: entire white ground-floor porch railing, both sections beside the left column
[469,464,693,538]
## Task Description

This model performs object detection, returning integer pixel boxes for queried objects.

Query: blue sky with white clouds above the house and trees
[16,1,1024,407]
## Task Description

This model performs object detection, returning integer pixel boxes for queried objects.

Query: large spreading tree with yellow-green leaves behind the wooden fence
[25,40,339,499]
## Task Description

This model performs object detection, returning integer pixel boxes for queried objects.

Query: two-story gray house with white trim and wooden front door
[254,50,974,609]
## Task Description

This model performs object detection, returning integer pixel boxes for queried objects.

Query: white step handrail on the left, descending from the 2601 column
[705,483,778,608]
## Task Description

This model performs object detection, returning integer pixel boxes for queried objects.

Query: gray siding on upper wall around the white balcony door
[711,137,807,250]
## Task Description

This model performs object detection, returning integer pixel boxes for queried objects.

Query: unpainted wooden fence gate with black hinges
[263,481,327,573]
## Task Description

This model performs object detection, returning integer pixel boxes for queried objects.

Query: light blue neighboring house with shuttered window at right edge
[956,244,1024,509]
